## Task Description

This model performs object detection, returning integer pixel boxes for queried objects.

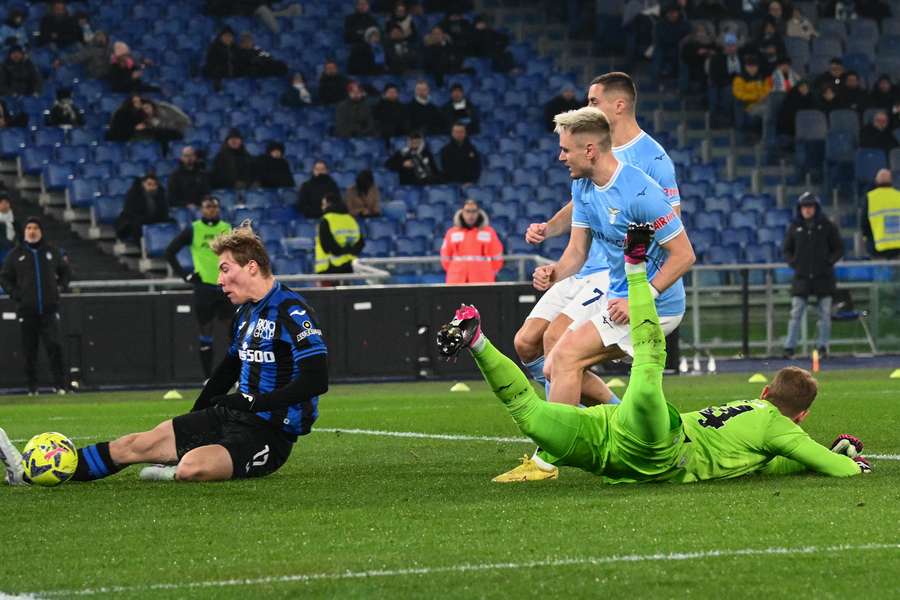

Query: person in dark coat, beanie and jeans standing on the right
[784,192,844,358]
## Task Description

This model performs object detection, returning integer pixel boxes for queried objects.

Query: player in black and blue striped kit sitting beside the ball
[0,227,328,484]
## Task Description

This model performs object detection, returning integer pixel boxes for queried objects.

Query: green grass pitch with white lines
[0,370,900,598]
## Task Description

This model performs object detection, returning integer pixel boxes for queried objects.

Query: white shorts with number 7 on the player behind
[528,270,609,325]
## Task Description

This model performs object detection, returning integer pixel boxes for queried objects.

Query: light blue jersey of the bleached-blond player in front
[572,162,685,317]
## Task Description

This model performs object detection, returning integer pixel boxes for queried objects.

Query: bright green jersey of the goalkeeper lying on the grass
[665,400,860,482]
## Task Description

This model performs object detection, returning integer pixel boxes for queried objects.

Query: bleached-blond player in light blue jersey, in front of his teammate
[535,107,695,404]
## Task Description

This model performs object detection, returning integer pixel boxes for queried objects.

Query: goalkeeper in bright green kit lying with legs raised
[437,223,871,483]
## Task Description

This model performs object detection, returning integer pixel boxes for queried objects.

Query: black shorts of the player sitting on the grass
[172,406,294,479]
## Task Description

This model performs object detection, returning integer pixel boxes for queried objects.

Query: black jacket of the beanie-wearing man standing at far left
[0,239,72,316]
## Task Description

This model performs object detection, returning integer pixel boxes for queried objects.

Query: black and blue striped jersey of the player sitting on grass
[228,281,328,437]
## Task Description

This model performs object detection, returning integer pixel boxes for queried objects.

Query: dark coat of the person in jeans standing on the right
[783,197,844,297]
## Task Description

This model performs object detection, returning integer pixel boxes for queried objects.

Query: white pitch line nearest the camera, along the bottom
[26,543,900,598]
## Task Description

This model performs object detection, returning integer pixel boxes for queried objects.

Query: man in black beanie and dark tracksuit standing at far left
[0,217,71,396]
